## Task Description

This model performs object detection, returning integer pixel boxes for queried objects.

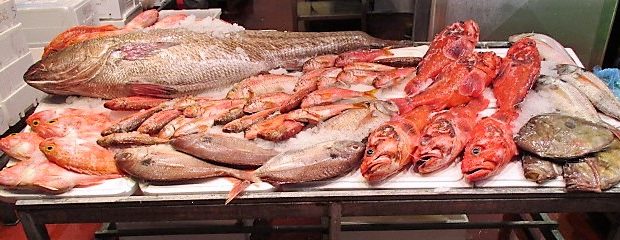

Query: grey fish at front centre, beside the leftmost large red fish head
[254,141,364,184]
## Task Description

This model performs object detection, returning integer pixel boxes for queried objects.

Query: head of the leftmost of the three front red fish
[360,124,412,182]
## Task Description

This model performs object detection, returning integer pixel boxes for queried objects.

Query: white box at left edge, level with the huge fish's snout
[0,52,34,100]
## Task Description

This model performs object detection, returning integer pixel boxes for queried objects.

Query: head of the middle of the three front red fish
[413,118,458,173]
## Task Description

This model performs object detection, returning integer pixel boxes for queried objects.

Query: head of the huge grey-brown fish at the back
[24,39,116,95]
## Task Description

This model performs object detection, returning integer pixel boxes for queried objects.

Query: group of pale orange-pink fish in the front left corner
[0,109,121,194]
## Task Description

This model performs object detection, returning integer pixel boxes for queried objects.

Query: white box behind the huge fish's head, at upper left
[15,0,99,48]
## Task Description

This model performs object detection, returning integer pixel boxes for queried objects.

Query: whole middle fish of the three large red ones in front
[413,98,488,174]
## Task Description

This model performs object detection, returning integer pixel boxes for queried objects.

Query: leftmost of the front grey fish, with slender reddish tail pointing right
[114,146,257,182]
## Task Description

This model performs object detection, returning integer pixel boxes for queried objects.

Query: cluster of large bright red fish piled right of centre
[361,20,540,182]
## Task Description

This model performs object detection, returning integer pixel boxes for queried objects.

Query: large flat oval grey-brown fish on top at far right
[515,114,615,159]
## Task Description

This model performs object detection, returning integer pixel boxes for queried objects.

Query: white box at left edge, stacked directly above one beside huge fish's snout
[0,23,28,69]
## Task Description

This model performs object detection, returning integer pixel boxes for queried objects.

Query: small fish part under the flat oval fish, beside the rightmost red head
[521,153,562,183]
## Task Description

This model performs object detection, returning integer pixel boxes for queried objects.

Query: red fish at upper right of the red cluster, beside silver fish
[493,38,540,111]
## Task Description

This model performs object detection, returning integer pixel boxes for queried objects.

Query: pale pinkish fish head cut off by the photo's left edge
[0,132,43,160]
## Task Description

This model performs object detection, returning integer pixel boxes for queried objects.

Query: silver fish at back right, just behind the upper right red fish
[508,33,577,65]
